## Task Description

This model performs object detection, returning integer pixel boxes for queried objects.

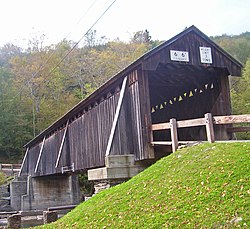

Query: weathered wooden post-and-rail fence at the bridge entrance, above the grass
[152,113,250,152]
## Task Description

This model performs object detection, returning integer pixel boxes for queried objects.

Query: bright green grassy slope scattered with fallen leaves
[40,143,250,228]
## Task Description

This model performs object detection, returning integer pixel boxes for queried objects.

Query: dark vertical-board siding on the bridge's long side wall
[22,70,153,176]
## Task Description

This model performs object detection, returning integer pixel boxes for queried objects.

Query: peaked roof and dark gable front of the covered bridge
[24,26,242,148]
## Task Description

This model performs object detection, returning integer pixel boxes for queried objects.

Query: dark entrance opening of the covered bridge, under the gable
[148,63,231,154]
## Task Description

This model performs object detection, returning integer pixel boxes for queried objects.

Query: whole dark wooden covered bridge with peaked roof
[11,26,242,208]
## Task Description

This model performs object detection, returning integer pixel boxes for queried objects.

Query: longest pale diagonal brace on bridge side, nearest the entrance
[105,76,127,156]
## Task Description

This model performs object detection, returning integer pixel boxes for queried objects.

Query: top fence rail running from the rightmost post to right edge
[213,114,250,125]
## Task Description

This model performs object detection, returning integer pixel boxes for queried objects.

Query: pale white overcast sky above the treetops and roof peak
[0,0,250,47]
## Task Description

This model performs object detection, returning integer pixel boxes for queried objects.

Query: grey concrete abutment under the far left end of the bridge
[10,174,80,211]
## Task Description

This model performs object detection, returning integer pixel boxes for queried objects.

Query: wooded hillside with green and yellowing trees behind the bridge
[0,30,250,163]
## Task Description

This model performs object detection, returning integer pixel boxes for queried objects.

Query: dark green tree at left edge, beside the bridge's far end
[0,67,32,161]
